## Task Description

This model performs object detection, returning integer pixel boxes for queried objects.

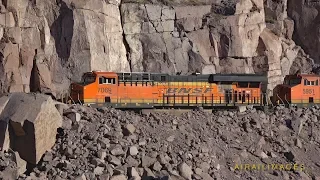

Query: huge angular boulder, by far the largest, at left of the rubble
[0,93,62,164]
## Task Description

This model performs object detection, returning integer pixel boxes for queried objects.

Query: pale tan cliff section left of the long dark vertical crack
[0,0,130,96]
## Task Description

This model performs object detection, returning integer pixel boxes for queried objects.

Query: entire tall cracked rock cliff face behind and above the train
[0,0,319,97]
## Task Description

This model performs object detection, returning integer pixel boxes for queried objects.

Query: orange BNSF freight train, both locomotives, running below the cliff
[70,71,320,109]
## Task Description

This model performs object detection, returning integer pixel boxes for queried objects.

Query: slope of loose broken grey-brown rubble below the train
[2,106,320,180]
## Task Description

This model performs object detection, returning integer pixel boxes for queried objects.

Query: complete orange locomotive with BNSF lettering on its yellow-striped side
[71,71,267,108]
